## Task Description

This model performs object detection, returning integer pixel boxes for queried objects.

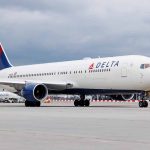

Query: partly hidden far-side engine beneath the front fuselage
[110,94,134,101]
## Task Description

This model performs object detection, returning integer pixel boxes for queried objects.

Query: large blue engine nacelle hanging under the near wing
[21,83,48,101]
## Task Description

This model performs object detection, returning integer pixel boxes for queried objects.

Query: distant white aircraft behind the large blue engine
[0,91,23,102]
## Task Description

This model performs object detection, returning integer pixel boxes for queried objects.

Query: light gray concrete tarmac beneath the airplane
[0,102,150,150]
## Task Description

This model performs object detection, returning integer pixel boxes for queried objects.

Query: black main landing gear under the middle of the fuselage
[74,95,90,107]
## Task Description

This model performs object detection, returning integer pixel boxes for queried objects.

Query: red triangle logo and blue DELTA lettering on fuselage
[89,61,119,70]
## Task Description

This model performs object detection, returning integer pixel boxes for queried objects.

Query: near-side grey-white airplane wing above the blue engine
[0,80,73,91]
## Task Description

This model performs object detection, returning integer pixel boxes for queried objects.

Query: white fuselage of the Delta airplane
[0,55,150,94]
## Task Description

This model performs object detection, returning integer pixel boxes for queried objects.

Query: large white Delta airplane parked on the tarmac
[0,44,150,107]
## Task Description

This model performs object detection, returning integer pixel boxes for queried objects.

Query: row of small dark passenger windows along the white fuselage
[8,69,110,78]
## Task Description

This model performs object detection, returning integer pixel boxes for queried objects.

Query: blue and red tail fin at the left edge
[0,43,12,70]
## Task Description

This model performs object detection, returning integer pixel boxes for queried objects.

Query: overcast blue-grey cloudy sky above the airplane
[0,0,150,65]
